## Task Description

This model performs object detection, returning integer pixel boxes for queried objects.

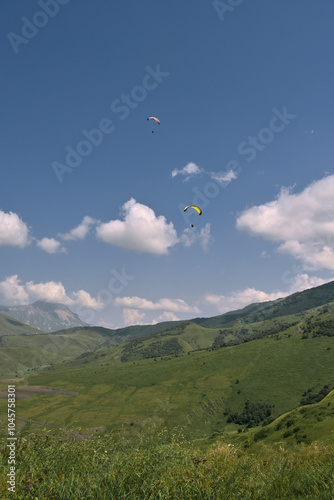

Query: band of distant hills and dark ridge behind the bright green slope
[0,283,334,378]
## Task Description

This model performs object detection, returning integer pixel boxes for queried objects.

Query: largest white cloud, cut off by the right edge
[237,175,334,270]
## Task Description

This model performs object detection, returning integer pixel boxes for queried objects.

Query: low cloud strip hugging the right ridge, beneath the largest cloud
[204,273,331,314]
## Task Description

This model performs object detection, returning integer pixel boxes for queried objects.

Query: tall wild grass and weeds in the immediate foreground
[0,428,334,500]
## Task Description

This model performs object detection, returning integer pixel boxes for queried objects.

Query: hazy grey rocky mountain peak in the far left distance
[0,300,87,332]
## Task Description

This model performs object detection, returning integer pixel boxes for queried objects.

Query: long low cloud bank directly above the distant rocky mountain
[0,274,104,310]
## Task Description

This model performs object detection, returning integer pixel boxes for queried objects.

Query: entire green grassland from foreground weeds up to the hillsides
[0,290,334,500]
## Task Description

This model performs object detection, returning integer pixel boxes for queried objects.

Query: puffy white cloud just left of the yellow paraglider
[96,198,178,255]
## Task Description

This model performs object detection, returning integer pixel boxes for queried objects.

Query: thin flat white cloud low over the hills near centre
[114,297,200,313]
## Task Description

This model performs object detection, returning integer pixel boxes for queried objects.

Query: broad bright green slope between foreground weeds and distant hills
[0,333,334,435]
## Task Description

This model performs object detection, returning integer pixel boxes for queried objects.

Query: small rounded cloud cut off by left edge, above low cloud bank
[0,210,29,248]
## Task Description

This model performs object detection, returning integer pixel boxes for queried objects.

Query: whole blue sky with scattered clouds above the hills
[0,0,334,328]
